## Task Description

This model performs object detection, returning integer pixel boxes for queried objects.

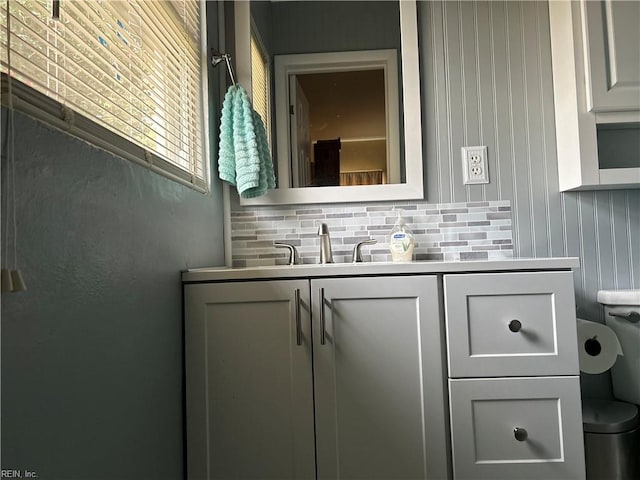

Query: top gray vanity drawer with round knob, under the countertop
[444,271,579,378]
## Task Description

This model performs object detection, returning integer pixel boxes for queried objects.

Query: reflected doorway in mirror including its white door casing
[275,50,400,188]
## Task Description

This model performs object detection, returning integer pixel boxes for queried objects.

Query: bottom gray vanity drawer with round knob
[449,376,585,480]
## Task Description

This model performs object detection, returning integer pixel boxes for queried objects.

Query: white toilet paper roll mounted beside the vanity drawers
[577,318,622,373]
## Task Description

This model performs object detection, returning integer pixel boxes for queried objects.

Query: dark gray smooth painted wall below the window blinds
[1,4,224,480]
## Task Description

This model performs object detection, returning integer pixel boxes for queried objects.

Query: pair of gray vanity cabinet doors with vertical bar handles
[185,275,449,480]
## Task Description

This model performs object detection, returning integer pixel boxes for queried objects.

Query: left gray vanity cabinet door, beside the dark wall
[185,280,315,480]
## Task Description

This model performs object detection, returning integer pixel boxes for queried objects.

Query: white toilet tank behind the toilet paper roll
[597,290,640,405]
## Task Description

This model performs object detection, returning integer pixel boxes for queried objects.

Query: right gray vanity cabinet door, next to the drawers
[311,276,448,480]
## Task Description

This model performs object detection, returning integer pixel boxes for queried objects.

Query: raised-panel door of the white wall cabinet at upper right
[581,0,640,112]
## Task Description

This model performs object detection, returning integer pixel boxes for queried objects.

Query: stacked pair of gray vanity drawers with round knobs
[444,272,585,480]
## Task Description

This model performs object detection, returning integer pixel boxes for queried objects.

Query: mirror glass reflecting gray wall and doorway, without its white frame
[250,1,400,187]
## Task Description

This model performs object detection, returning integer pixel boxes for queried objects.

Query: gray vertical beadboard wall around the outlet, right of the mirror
[419,2,640,396]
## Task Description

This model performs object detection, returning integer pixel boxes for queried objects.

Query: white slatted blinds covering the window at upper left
[0,0,208,190]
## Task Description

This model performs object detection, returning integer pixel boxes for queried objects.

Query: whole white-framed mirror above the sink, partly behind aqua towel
[235,0,423,203]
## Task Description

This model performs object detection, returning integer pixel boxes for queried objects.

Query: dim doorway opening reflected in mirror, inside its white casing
[298,69,387,187]
